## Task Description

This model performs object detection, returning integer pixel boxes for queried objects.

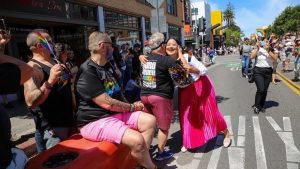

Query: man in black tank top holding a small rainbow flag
[24,30,75,153]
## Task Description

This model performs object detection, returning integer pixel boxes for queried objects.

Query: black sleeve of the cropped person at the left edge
[0,63,21,94]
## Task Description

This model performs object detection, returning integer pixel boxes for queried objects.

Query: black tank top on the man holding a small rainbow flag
[29,59,75,130]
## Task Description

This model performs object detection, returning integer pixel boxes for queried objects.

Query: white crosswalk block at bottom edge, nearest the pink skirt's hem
[228,147,245,169]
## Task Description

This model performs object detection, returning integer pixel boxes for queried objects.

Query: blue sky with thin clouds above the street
[191,0,300,36]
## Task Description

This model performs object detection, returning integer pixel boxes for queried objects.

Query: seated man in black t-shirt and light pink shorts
[75,32,157,169]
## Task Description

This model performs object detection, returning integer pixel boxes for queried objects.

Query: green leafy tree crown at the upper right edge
[270,5,300,36]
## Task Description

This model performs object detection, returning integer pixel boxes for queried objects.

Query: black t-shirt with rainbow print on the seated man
[75,59,123,127]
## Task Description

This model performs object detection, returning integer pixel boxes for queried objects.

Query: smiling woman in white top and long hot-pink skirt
[166,38,231,152]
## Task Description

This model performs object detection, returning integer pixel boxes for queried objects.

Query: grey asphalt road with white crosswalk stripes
[153,56,300,169]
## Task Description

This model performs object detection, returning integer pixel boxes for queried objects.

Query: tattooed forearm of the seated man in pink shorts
[93,93,144,112]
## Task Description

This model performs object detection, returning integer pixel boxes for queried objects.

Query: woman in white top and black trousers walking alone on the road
[251,41,277,114]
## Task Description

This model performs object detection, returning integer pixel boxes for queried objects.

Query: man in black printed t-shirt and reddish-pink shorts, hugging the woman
[141,32,176,161]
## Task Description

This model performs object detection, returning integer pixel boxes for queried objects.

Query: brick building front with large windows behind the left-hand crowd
[0,0,183,61]
